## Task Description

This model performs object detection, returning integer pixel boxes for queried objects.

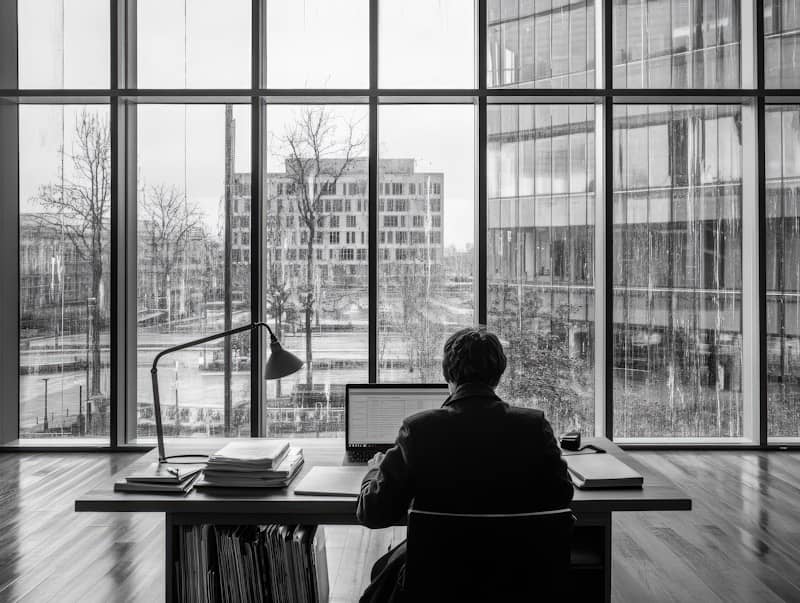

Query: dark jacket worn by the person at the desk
[357,384,573,528]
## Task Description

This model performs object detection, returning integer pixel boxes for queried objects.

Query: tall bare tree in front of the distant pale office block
[280,106,366,391]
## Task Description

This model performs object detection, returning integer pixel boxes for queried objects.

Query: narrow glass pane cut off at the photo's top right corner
[764,0,800,88]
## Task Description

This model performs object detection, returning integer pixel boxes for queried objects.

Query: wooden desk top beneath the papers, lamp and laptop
[75,438,692,525]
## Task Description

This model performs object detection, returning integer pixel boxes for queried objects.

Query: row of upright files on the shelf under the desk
[176,525,329,603]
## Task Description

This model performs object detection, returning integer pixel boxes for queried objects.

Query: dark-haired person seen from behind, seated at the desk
[357,328,573,603]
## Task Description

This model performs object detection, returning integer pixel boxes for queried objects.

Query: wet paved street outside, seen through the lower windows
[20,332,454,432]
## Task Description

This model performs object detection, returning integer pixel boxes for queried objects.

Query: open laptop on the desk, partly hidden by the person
[344,383,450,464]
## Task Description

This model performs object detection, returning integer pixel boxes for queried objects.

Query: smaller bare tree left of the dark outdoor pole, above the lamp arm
[139,184,201,330]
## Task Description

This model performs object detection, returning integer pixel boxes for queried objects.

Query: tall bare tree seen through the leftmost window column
[35,111,111,396]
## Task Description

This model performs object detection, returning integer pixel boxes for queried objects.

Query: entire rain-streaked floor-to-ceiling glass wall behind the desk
[9,0,800,443]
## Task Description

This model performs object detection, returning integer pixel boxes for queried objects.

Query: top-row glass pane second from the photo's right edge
[612,0,741,88]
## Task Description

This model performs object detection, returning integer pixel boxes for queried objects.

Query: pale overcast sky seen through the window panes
[19,0,475,248]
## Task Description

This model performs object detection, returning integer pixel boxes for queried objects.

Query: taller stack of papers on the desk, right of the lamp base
[196,438,303,488]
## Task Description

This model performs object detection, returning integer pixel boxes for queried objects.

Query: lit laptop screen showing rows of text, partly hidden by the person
[347,385,448,446]
